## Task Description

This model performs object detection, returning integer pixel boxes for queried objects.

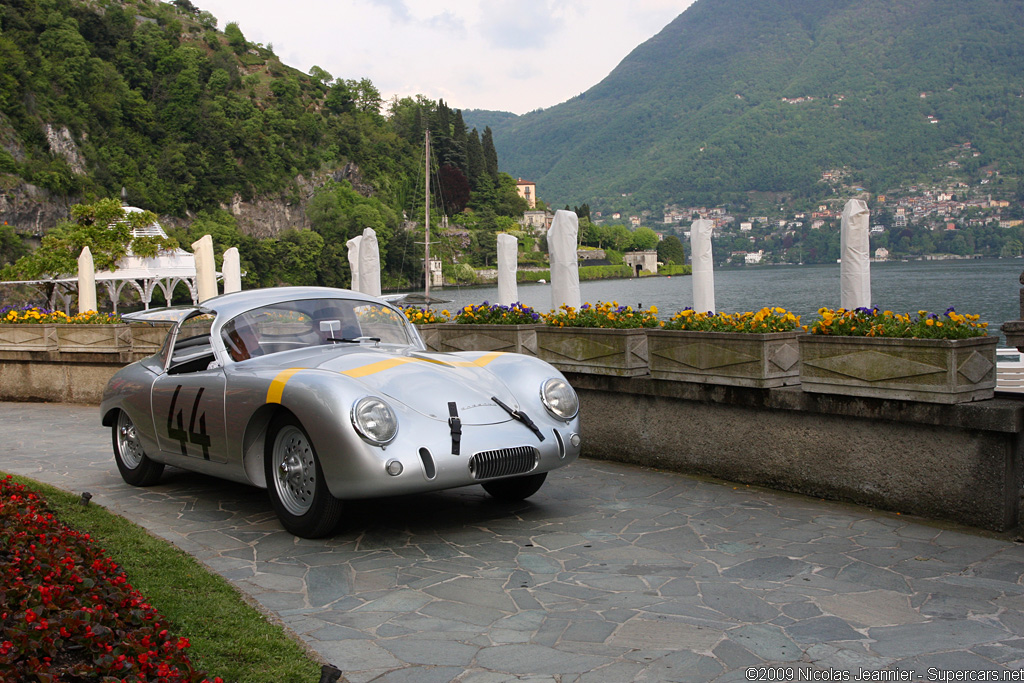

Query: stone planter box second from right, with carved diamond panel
[647,329,804,389]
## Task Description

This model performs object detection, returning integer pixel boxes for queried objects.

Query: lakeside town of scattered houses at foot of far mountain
[552,156,1024,265]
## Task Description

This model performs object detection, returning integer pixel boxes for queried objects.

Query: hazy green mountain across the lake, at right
[494,0,1024,212]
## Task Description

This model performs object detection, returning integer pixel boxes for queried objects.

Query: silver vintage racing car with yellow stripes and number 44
[100,287,580,538]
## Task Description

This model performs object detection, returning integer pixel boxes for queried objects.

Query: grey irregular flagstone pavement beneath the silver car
[6,403,1024,683]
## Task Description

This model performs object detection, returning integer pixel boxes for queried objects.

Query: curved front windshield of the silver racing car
[220,299,414,361]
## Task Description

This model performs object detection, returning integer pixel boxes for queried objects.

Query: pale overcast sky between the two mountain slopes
[194,0,693,114]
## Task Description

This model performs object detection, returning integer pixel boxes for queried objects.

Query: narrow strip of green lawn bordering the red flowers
[0,472,321,683]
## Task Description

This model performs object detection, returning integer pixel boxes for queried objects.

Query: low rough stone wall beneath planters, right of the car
[568,374,1024,530]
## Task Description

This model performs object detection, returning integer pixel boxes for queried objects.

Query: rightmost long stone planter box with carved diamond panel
[800,335,998,403]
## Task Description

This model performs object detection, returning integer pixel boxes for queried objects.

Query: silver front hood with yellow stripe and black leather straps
[318,348,519,425]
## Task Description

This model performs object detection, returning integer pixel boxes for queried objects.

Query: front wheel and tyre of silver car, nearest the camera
[263,414,342,539]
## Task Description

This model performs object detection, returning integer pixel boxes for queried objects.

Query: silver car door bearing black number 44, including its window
[152,313,227,468]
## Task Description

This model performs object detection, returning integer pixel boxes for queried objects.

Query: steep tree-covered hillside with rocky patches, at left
[0,0,524,286]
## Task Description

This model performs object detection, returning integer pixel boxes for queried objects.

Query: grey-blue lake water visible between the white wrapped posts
[411,259,1024,342]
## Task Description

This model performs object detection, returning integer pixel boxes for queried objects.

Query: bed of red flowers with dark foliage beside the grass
[0,477,220,683]
